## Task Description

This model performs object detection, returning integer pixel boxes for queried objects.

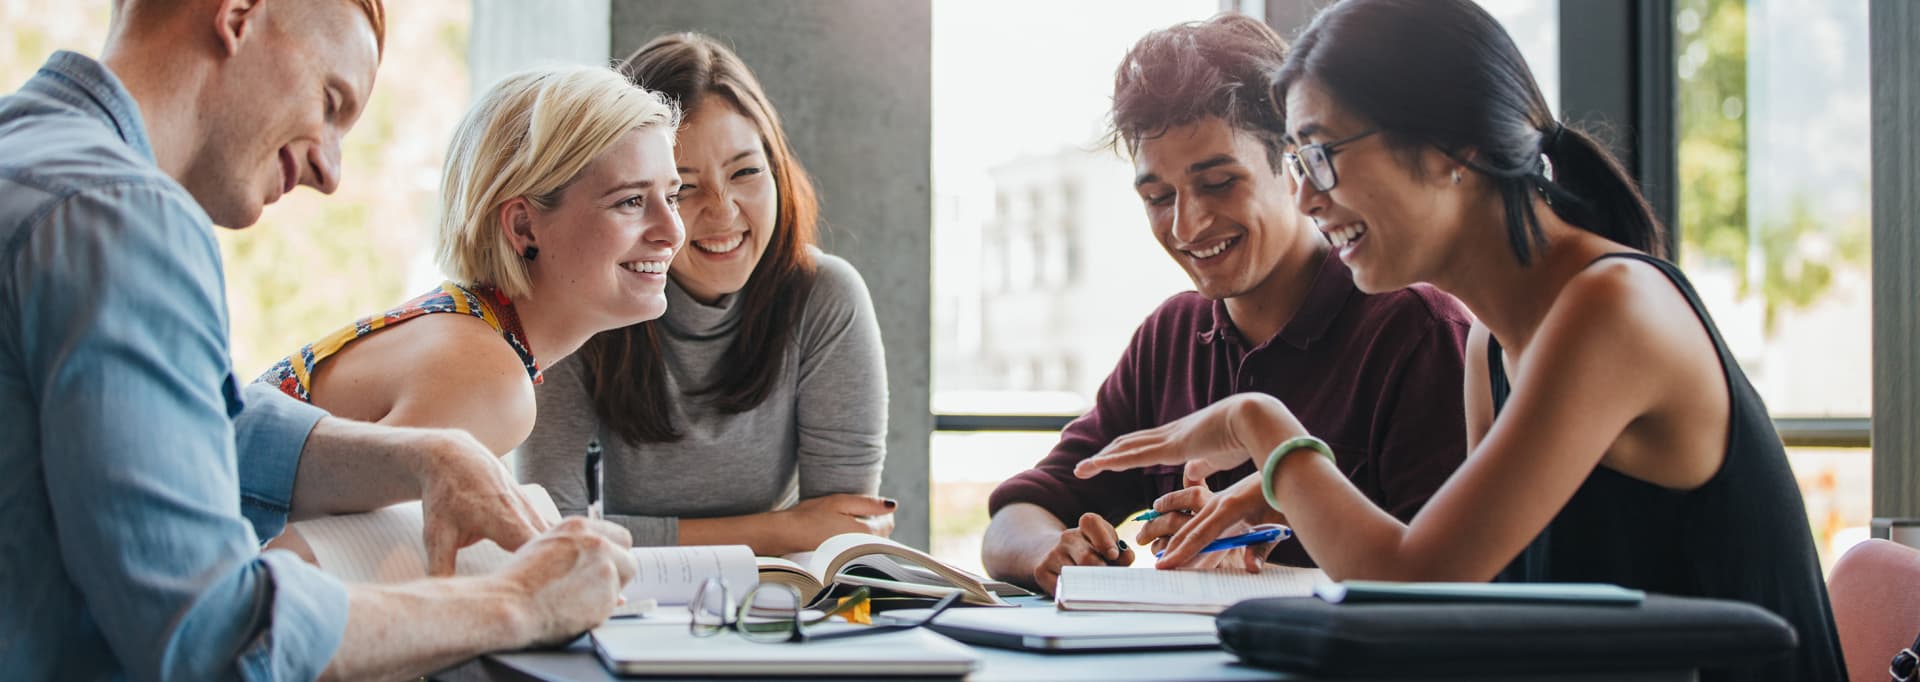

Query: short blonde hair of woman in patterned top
[434,65,680,298]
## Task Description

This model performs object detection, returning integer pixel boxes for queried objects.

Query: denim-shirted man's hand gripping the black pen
[499,517,637,644]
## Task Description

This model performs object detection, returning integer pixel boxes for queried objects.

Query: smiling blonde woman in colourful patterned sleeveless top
[259,67,685,453]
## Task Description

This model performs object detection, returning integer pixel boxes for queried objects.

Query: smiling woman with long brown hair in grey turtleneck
[518,33,893,553]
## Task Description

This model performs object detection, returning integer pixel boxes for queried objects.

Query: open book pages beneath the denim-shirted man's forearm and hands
[292,484,561,582]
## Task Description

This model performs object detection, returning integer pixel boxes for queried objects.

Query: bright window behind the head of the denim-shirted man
[0,0,470,380]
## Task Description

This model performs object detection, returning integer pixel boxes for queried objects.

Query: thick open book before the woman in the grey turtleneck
[758,532,1031,605]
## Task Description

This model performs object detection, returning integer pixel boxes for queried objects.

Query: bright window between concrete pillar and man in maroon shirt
[929,0,1219,569]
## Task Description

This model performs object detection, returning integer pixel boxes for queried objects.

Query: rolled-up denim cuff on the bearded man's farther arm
[234,382,326,540]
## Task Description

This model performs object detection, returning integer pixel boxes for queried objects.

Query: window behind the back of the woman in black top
[1674,0,1872,561]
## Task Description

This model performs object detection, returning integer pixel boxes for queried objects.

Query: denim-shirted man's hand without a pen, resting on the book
[413,428,552,576]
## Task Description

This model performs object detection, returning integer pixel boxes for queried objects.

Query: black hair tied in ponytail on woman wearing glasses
[1273,0,1668,265]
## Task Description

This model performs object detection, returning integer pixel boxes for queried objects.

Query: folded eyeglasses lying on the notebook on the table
[687,578,960,642]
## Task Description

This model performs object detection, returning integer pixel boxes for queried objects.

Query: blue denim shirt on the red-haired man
[0,52,348,680]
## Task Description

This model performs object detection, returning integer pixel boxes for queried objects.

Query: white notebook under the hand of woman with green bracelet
[1054,565,1331,613]
